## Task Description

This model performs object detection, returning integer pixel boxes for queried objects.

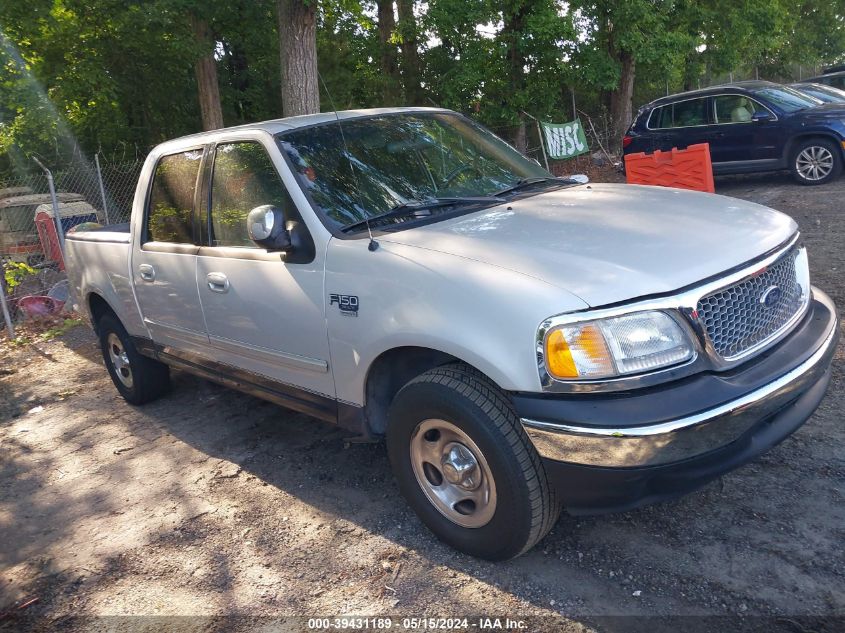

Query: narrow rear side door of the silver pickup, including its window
[132,148,208,354]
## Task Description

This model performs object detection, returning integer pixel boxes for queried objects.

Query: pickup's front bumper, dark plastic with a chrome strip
[513,289,839,513]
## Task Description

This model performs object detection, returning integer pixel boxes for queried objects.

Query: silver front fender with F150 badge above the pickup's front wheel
[326,239,587,405]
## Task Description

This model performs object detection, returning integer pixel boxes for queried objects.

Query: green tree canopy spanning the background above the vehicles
[0,0,845,172]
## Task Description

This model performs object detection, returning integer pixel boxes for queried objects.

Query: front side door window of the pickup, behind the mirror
[211,141,293,248]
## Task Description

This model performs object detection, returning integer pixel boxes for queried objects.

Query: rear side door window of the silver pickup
[147,150,202,244]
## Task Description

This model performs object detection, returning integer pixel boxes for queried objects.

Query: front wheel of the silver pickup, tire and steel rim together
[387,365,560,560]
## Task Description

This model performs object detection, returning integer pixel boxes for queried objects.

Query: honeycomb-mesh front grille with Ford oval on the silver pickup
[698,248,805,360]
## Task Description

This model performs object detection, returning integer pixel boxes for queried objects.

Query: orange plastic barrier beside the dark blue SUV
[625,143,716,193]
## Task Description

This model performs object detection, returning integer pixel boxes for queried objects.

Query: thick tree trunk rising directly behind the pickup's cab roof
[278,0,320,116]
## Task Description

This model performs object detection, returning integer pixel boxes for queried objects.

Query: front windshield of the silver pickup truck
[277,112,551,228]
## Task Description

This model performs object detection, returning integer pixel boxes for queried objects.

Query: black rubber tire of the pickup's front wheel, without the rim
[387,364,560,560]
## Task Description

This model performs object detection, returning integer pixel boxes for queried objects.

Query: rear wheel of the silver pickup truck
[97,314,170,405]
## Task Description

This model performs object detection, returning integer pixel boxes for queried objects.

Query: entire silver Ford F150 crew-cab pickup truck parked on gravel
[67,108,839,559]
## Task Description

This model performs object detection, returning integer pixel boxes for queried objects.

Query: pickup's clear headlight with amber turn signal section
[545,311,694,380]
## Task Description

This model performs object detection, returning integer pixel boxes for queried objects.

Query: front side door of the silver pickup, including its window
[196,139,335,400]
